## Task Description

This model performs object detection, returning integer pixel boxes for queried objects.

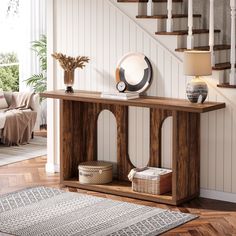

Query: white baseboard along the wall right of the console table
[200,189,236,203]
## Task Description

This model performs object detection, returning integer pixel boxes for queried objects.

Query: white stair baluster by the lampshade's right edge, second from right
[209,0,215,66]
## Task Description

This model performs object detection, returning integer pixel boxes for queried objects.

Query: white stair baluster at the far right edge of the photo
[230,0,236,85]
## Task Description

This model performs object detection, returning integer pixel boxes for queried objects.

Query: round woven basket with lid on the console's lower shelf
[78,161,112,184]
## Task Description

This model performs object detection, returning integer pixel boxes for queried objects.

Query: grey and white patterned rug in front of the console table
[0,187,197,236]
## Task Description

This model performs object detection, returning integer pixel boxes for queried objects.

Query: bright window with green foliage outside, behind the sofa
[0,0,20,91]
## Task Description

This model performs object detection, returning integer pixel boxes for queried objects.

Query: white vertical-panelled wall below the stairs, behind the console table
[48,0,236,199]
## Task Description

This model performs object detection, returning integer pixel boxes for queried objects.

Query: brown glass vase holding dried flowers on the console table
[52,53,89,93]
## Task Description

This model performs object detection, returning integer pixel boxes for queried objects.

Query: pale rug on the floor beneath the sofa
[0,136,47,166]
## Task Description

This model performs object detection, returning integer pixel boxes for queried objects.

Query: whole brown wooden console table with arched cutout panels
[41,91,225,205]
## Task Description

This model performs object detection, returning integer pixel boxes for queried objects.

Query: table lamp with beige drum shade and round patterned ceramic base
[184,51,212,103]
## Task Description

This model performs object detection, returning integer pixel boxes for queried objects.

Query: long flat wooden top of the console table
[40,90,225,113]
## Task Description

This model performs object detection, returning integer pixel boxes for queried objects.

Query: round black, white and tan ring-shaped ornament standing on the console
[116,52,152,93]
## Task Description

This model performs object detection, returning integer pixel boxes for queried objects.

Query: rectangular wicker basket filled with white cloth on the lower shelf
[129,167,172,195]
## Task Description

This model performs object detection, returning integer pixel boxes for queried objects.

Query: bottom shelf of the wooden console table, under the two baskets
[62,179,176,205]
